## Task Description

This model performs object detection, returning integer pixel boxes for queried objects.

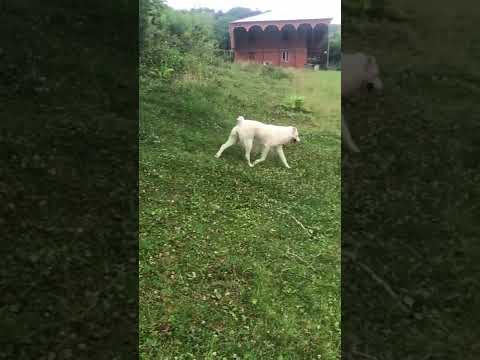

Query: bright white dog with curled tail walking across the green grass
[215,116,300,168]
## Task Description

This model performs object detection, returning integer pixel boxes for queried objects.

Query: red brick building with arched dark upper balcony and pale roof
[229,12,332,67]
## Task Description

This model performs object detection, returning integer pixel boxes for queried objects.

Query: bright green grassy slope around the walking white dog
[139,65,340,359]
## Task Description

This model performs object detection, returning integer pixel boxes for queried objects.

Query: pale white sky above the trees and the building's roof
[167,0,341,24]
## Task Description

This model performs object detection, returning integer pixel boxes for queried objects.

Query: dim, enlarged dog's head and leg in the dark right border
[342,53,383,152]
